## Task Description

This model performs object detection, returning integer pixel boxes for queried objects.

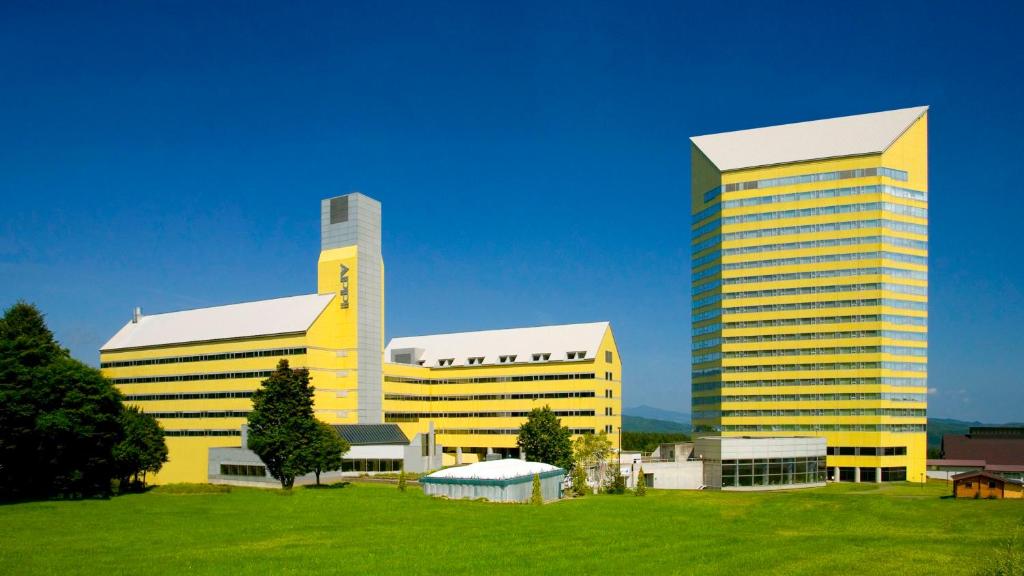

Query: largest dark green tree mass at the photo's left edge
[0,301,122,499]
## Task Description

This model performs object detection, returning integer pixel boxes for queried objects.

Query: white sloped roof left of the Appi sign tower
[99,294,334,351]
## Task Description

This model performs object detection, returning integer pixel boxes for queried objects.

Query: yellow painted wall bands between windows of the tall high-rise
[692,115,928,482]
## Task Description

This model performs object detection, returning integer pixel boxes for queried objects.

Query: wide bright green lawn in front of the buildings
[0,483,1024,576]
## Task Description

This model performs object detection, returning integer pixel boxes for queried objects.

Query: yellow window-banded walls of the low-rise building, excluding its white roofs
[100,191,622,484]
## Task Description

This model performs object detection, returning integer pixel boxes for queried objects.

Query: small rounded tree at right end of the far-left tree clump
[114,406,167,492]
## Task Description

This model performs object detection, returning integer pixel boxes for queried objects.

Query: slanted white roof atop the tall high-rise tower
[690,106,928,171]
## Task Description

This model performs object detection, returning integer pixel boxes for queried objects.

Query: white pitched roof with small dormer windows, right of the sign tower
[384,322,608,367]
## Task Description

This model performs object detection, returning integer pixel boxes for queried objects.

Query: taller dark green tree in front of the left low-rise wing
[249,360,318,489]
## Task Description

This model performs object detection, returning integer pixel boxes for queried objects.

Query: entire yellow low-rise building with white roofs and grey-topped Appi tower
[100,194,622,483]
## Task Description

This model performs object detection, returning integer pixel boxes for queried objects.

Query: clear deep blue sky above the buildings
[0,0,1024,421]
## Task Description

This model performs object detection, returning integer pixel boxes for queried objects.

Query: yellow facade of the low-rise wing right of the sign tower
[384,328,622,463]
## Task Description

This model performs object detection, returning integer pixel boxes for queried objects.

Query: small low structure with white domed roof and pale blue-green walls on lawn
[420,458,565,502]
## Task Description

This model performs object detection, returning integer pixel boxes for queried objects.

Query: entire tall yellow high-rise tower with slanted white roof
[691,107,928,485]
